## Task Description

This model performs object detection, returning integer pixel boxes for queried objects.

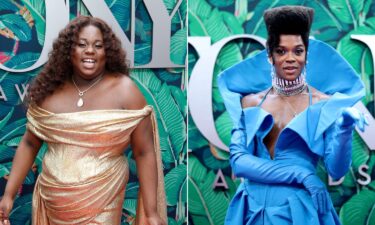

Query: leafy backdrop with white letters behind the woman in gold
[0,0,187,225]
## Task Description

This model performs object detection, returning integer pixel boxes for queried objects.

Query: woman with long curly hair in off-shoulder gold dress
[0,16,167,225]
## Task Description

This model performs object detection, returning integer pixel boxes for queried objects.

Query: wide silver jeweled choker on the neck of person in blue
[272,75,307,96]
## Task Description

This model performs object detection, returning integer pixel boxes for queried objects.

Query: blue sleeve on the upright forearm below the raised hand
[323,120,354,179]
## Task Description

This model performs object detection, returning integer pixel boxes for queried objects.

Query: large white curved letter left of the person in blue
[188,34,266,151]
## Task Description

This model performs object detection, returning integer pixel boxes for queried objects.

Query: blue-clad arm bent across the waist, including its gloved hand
[229,116,330,214]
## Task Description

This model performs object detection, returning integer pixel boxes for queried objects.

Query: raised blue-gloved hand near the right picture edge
[337,107,369,132]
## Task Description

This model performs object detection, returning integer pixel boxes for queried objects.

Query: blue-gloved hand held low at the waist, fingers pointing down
[302,174,331,214]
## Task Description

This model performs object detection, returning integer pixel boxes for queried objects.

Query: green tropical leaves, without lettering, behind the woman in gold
[0,0,187,225]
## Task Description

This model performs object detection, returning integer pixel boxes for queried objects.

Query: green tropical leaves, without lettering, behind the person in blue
[188,0,375,225]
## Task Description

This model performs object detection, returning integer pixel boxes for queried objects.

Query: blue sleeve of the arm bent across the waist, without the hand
[229,113,314,184]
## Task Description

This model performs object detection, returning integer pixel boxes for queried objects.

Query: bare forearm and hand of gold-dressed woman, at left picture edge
[0,129,42,222]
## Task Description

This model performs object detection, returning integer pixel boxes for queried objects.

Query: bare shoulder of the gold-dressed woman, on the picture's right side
[113,74,146,109]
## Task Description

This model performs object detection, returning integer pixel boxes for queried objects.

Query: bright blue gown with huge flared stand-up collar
[218,40,364,225]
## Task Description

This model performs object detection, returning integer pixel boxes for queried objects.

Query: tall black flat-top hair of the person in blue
[263,6,314,56]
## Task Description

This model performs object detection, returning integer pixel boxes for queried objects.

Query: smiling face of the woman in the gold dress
[71,25,106,80]
